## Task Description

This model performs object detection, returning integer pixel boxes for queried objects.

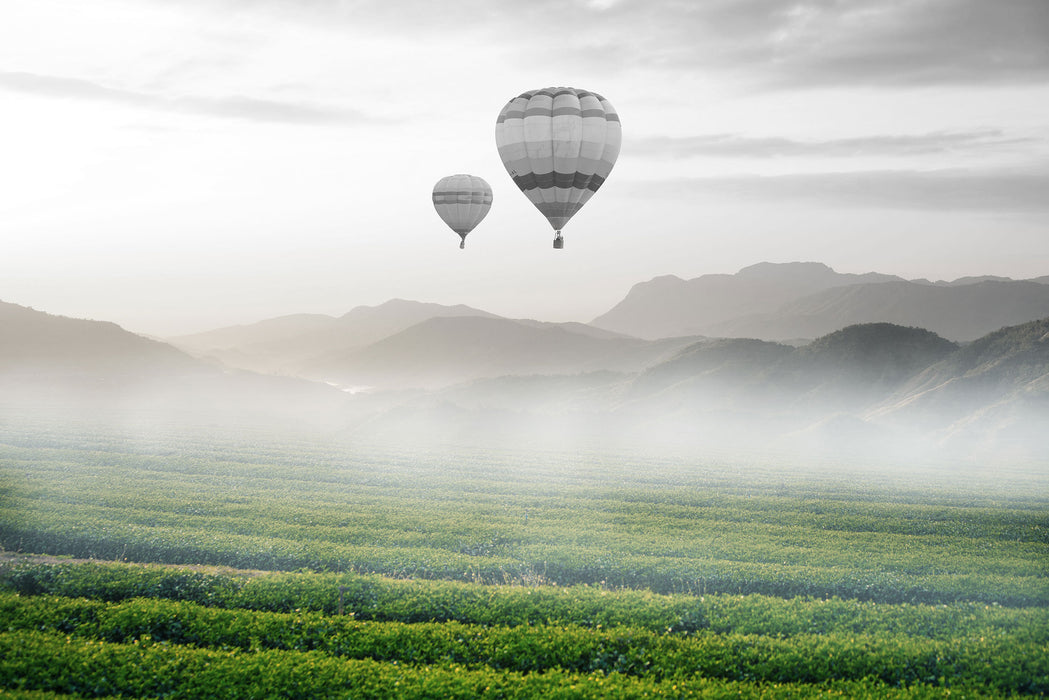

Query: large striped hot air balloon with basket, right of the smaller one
[495,87,622,248]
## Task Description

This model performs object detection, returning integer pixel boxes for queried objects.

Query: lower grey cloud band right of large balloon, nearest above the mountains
[631,167,1049,214]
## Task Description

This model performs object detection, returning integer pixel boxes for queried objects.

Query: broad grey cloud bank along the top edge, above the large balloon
[131,0,1049,88]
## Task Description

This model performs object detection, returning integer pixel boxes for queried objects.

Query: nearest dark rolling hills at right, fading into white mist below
[358,319,1049,460]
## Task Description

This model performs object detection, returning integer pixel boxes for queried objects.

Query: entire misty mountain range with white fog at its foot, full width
[0,262,1049,460]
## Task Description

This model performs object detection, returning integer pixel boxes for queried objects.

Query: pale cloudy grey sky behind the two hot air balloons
[0,0,1049,337]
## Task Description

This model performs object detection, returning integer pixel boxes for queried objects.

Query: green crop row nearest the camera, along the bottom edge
[0,632,1011,700]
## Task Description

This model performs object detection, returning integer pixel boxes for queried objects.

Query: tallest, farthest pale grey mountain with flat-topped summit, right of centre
[591,262,902,339]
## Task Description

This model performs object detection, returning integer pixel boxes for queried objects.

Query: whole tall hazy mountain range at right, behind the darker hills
[594,262,1049,341]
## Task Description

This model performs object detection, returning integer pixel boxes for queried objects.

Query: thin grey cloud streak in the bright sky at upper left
[0,71,377,126]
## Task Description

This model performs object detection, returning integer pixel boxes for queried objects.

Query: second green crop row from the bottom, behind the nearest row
[0,594,1049,693]
